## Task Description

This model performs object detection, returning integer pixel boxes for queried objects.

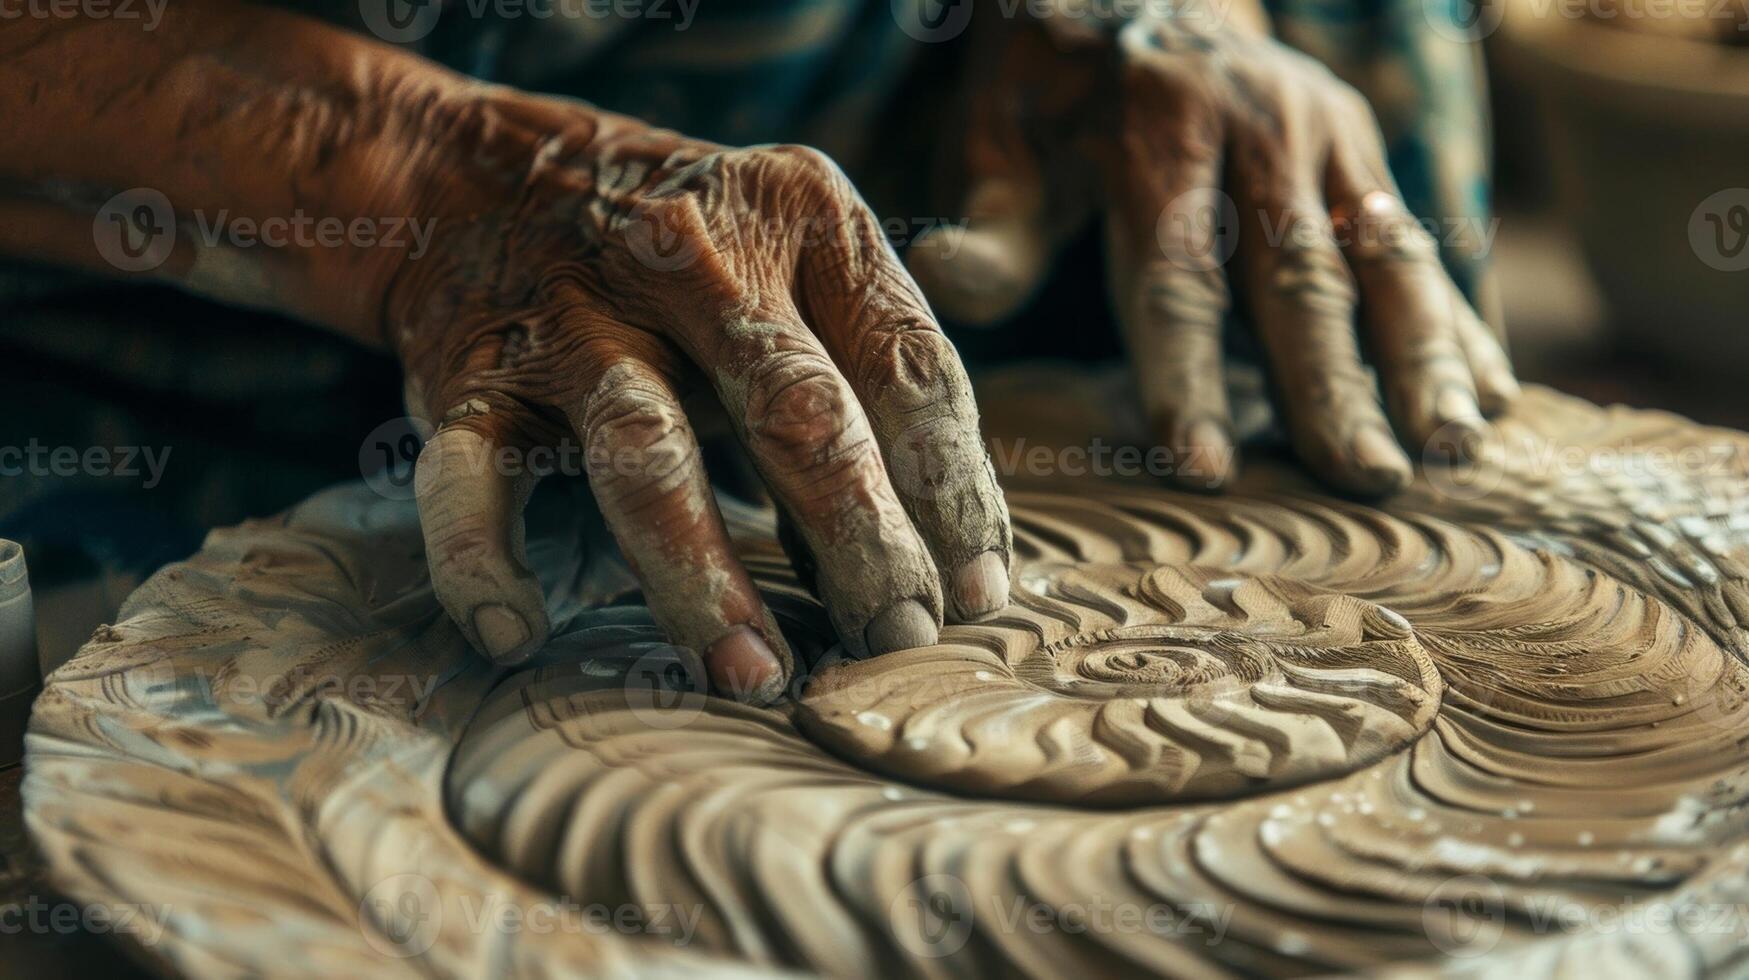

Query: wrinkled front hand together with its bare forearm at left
[0,0,1009,698]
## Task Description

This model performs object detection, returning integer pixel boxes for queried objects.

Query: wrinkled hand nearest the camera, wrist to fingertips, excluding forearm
[385,89,1011,700]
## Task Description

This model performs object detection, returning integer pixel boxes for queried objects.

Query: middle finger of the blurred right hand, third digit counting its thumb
[1238,180,1413,494]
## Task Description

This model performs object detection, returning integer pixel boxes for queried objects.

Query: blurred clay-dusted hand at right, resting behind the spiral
[908,7,1516,494]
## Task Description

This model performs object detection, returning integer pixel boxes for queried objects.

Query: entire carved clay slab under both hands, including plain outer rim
[24,390,1749,977]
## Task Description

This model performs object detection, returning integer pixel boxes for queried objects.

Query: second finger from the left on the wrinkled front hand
[565,350,794,704]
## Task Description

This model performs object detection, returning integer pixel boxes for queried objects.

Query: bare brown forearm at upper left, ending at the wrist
[0,0,470,343]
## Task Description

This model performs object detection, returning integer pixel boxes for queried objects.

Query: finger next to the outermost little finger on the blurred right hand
[1331,185,1485,446]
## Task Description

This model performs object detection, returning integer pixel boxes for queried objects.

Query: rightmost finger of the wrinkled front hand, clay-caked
[799,205,1013,620]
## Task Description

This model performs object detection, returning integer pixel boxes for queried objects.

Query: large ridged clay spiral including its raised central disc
[449,476,1749,975]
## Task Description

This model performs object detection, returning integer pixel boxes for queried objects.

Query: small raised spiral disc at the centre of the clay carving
[798,562,1439,803]
